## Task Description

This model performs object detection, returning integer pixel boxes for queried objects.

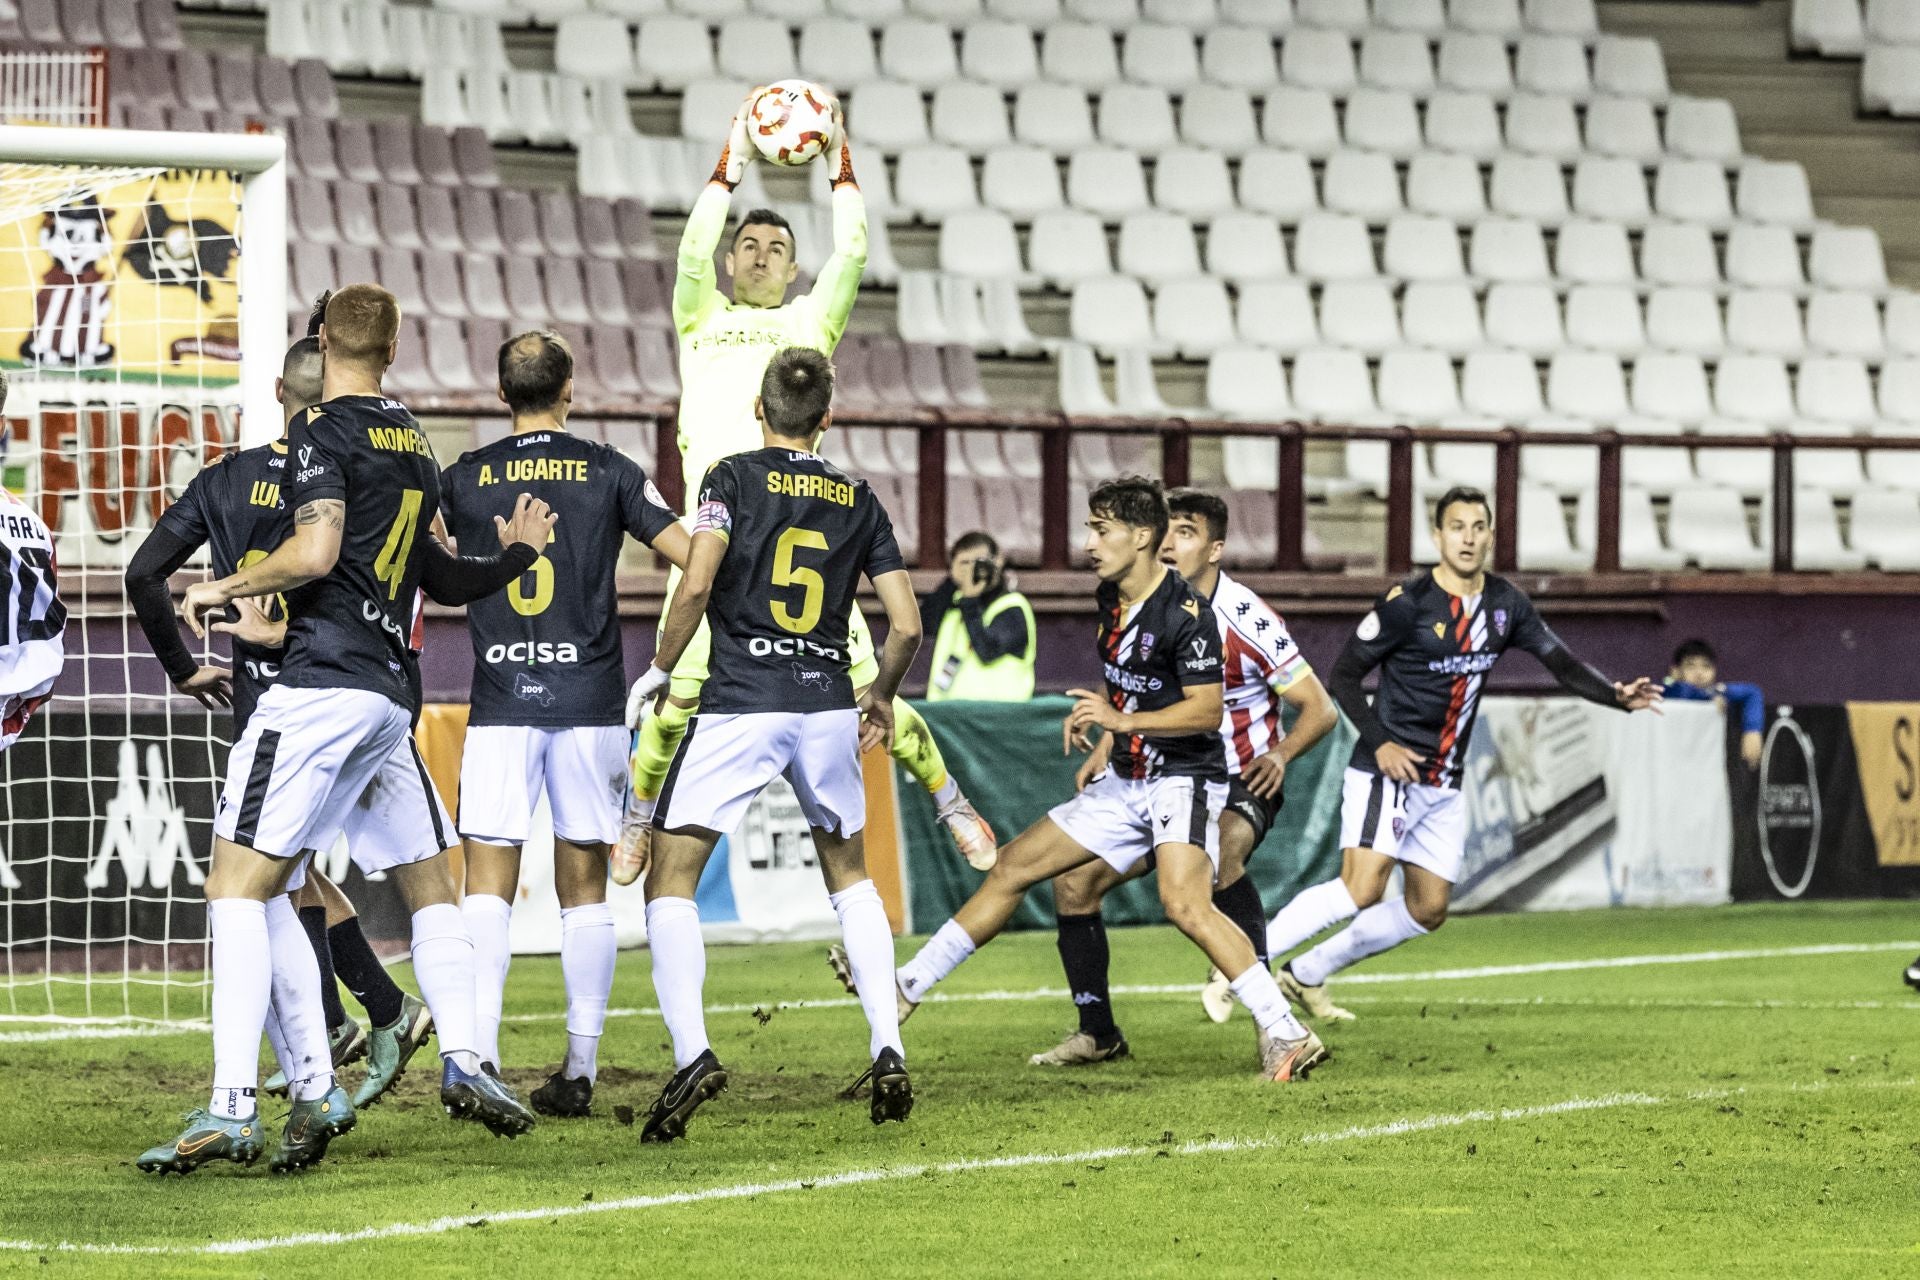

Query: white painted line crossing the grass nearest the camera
[0,1094,1672,1257]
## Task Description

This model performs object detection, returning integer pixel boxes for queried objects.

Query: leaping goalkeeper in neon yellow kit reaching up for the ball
[612,90,995,885]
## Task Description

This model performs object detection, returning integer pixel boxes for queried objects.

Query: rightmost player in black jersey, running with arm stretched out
[1267,487,1661,1019]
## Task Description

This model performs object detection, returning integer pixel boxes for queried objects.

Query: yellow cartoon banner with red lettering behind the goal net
[0,171,240,566]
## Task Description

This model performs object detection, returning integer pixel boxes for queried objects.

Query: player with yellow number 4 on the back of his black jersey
[138,284,553,1173]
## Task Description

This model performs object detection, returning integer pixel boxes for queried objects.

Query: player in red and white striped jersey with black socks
[1031,489,1340,1067]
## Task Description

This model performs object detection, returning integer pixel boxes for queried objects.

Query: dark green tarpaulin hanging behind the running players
[897,697,1354,933]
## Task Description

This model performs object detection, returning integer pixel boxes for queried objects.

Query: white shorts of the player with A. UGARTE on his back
[459,725,632,844]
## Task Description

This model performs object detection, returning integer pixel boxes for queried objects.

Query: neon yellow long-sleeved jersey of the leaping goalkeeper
[674,182,866,510]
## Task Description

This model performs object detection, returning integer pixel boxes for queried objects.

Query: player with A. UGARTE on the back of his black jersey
[440,330,687,1115]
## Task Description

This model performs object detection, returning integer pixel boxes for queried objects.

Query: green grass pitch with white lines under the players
[0,904,1920,1280]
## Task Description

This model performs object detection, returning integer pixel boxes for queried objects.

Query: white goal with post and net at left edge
[0,127,286,1019]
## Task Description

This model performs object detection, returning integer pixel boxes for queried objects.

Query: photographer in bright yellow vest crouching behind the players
[924,532,1035,702]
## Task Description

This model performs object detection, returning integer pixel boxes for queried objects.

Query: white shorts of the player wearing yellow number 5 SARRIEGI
[653,706,866,839]
